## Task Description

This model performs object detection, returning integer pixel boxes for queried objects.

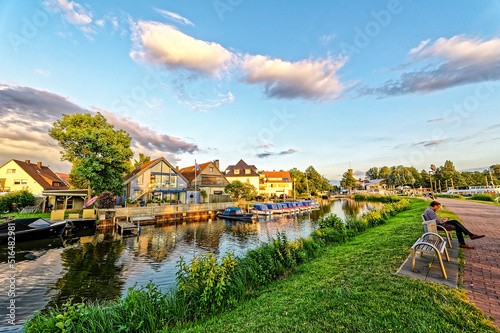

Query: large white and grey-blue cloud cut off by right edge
[364,35,500,96]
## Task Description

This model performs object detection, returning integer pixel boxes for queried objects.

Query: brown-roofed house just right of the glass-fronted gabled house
[179,160,229,202]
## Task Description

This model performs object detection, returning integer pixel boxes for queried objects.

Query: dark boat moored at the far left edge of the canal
[0,217,67,244]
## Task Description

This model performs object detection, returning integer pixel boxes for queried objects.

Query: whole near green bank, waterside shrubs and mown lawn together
[25,197,497,332]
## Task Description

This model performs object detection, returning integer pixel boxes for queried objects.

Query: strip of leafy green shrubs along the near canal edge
[25,198,409,332]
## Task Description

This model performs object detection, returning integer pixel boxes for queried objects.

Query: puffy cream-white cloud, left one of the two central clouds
[130,21,233,76]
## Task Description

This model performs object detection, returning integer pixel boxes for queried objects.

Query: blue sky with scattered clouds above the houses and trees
[0,0,500,180]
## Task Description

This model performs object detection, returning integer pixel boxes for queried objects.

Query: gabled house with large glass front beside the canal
[122,157,189,204]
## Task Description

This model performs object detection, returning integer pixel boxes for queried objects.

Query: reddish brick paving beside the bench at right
[437,198,500,328]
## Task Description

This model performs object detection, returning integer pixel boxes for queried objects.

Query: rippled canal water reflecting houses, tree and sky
[0,199,379,331]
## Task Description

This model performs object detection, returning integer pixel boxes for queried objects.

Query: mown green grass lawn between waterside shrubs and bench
[169,199,498,333]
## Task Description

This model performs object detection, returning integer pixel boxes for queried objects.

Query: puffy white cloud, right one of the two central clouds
[241,55,346,100]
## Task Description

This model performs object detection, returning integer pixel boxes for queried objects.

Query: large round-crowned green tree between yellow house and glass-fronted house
[49,113,133,195]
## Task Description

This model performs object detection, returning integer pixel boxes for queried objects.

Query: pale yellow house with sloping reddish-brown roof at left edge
[0,160,69,195]
